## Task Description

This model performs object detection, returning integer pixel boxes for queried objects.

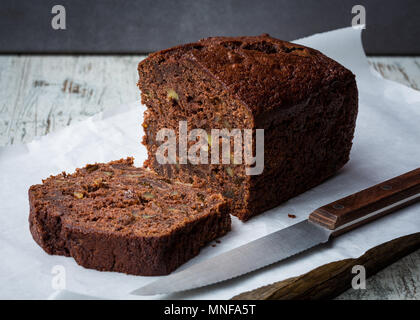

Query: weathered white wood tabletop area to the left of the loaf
[0,56,146,145]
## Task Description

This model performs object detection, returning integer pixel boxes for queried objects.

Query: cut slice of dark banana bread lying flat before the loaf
[29,158,230,276]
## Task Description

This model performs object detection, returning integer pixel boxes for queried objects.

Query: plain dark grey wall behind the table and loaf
[0,0,420,55]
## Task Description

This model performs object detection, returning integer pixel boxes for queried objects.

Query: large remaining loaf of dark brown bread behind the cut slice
[138,35,358,221]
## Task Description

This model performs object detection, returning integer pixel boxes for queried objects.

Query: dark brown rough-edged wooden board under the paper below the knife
[233,233,420,300]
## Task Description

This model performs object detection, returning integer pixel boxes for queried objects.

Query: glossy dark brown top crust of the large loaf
[138,34,354,118]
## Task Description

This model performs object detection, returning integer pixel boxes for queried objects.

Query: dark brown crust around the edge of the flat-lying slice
[29,159,230,276]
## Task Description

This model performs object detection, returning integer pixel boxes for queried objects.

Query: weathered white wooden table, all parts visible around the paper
[0,55,420,299]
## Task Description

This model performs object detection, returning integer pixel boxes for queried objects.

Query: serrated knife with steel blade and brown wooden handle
[131,168,420,295]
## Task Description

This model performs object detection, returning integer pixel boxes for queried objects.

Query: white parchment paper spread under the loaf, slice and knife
[0,28,420,299]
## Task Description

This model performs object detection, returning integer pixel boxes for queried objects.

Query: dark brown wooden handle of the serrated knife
[309,168,420,236]
